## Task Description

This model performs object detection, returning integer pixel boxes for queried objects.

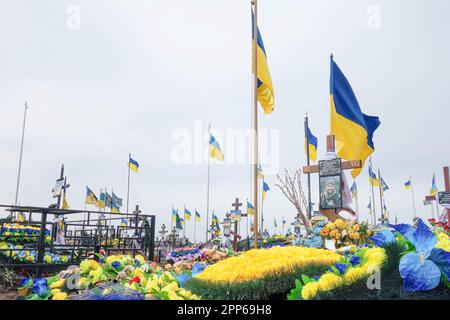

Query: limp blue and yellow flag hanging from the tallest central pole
[252,11,275,114]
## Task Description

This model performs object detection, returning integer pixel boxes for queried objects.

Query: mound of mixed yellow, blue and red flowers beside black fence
[19,255,203,300]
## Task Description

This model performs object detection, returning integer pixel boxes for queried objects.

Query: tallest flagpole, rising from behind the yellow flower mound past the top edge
[252,0,259,249]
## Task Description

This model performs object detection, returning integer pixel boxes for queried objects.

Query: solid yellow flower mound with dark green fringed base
[186,246,341,299]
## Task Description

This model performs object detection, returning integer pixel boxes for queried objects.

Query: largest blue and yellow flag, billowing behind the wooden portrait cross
[330,55,380,178]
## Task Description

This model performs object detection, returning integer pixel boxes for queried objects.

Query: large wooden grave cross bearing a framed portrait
[303,135,362,221]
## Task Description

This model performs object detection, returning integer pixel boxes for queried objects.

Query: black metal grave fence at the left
[0,205,156,276]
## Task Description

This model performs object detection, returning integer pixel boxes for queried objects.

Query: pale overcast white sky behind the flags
[0,0,450,240]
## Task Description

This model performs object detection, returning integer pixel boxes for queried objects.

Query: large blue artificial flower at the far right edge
[396,219,450,292]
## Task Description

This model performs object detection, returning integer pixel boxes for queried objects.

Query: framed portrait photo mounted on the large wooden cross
[319,175,342,210]
